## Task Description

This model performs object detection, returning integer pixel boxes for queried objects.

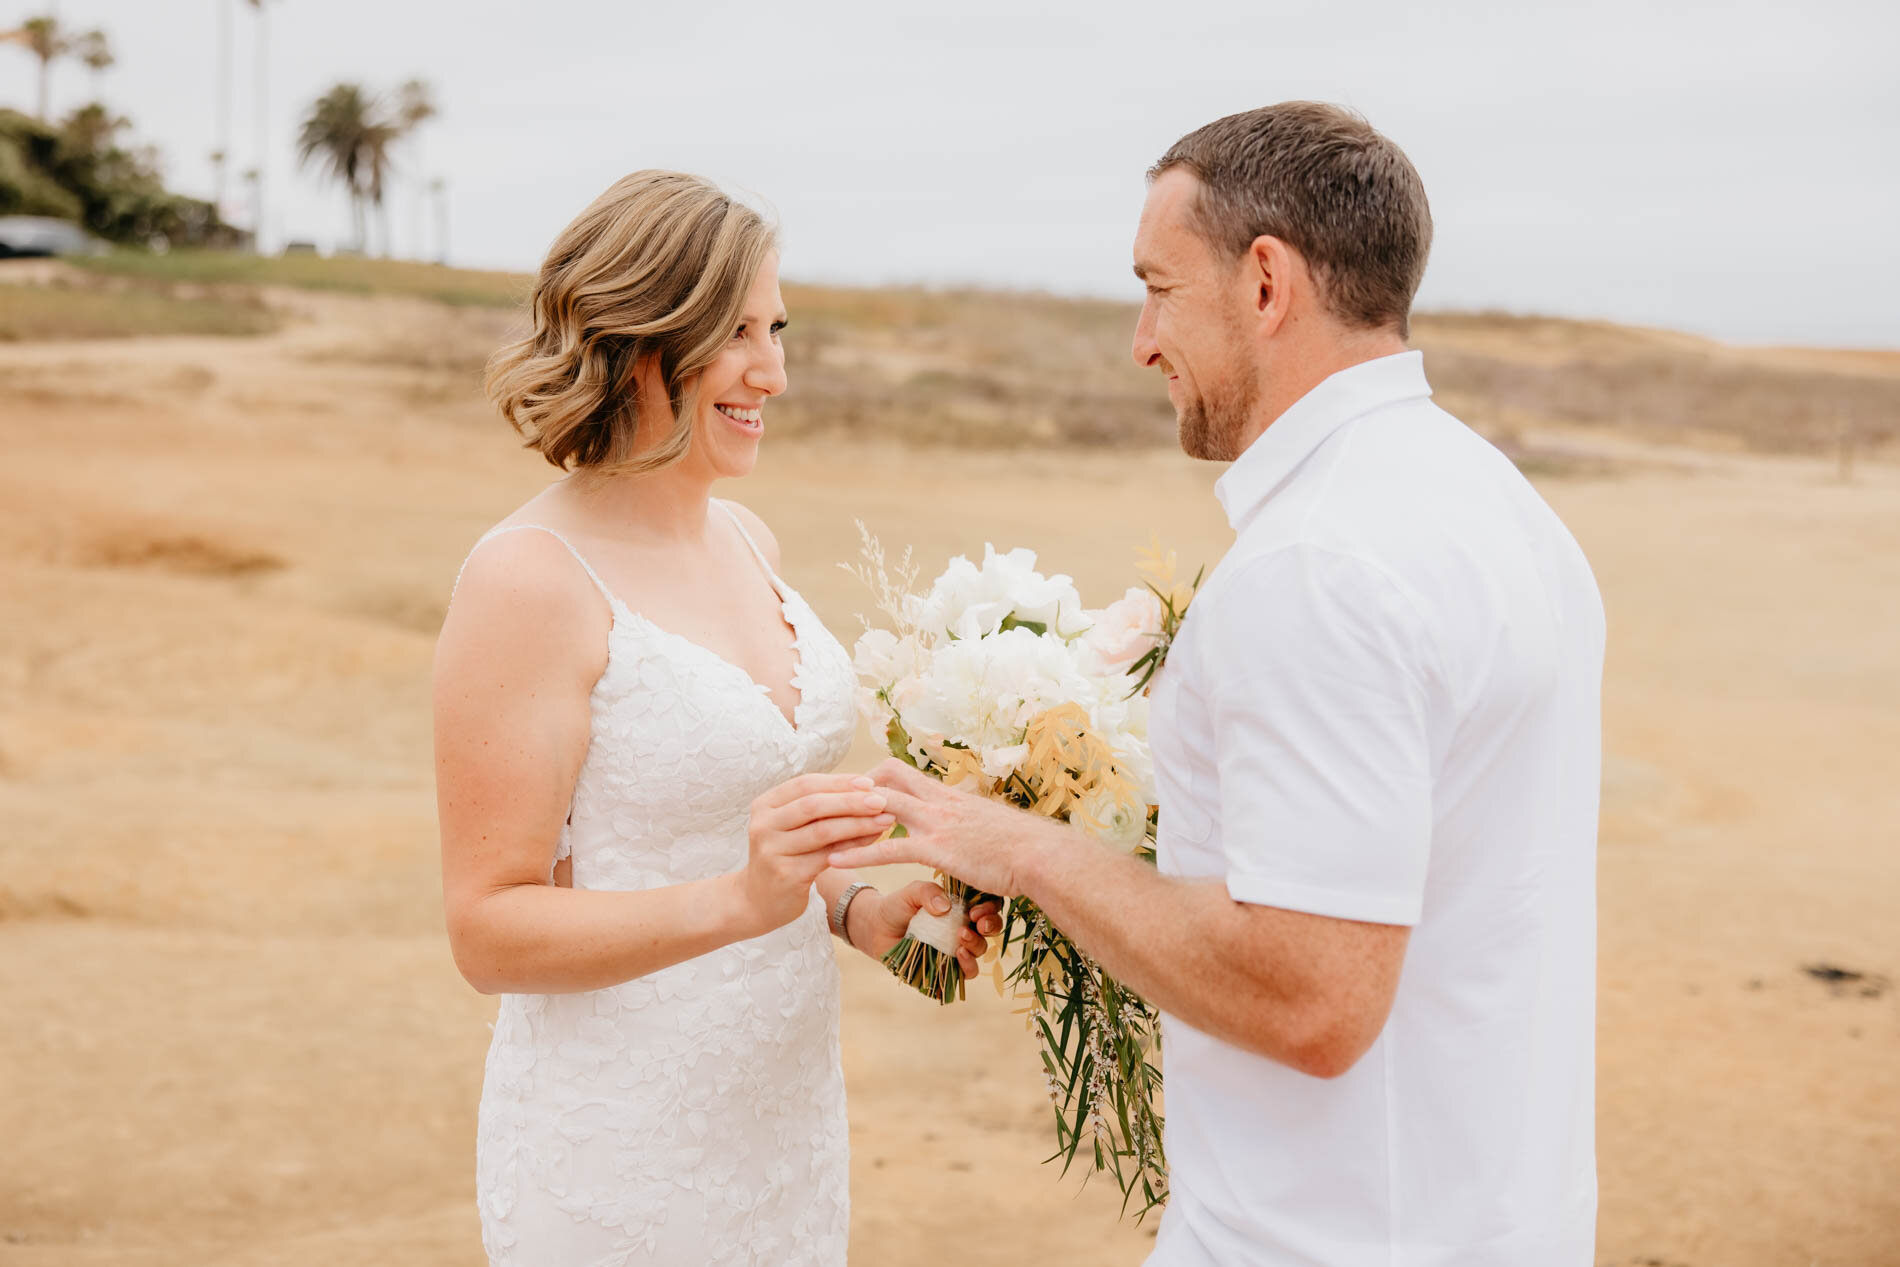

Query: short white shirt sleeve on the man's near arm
[1203,545,1433,925]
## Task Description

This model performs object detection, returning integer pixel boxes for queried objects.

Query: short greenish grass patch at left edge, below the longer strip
[0,285,277,342]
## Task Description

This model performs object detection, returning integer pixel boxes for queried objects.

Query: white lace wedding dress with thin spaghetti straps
[456,503,857,1267]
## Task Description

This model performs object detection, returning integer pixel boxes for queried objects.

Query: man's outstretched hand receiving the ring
[830,758,1062,897]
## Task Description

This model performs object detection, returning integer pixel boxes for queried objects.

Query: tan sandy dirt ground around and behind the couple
[0,294,1900,1267]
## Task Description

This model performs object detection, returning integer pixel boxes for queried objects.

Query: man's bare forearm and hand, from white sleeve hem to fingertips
[832,760,1410,1077]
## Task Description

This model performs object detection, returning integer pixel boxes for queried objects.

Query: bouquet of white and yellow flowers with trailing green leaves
[846,524,1201,1216]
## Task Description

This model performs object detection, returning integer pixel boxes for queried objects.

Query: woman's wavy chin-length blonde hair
[486,171,777,473]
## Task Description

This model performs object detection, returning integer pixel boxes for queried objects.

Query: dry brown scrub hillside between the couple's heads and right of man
[785,287,1900,461]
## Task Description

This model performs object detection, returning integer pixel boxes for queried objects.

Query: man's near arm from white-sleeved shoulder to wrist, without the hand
[1056,543,1440,1075]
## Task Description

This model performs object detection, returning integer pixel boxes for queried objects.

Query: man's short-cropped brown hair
[1148,101,1431,334]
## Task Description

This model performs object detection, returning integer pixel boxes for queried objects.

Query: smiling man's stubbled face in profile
[1132,167,1260,462]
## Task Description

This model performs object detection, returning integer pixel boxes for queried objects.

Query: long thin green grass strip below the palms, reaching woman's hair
[68,251,534,308]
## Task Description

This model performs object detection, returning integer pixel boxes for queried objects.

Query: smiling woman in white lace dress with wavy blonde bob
[435,171,996,1267]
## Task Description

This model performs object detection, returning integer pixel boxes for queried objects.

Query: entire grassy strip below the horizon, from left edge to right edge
[44,253,1900,460]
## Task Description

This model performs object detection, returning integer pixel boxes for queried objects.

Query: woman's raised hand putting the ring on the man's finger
[739,775,895,933]
